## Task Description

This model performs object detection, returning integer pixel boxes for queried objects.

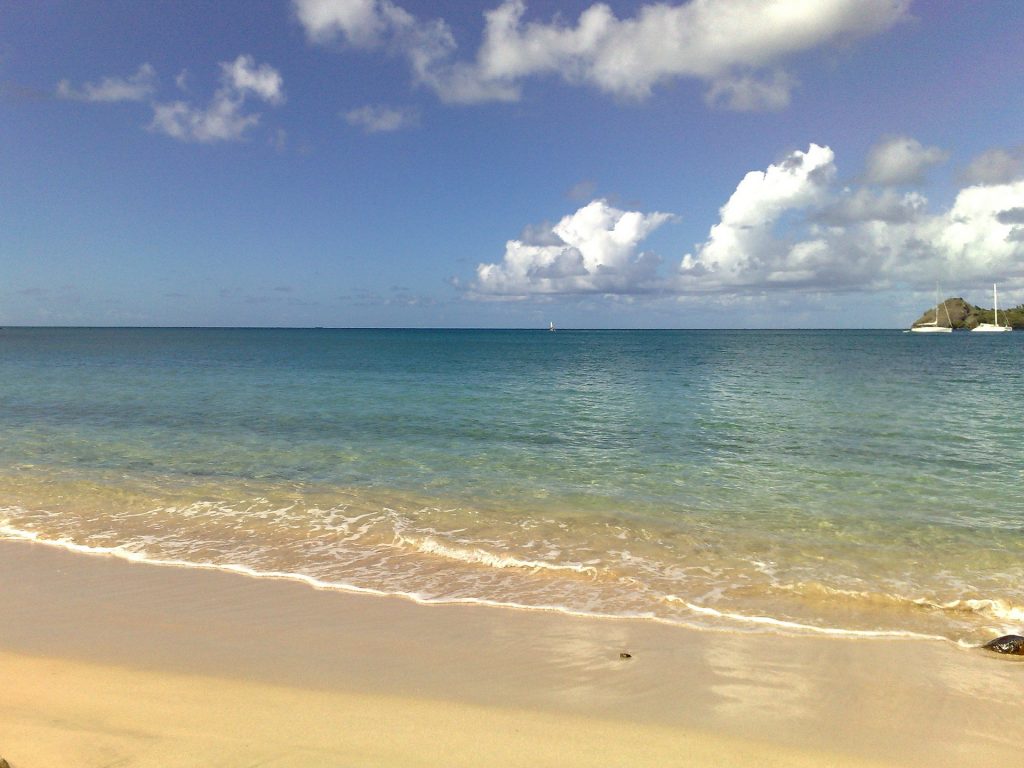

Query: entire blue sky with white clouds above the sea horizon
[0,0,1024,328]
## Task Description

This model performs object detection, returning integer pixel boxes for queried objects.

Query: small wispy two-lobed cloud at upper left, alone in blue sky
[150,55,285,142]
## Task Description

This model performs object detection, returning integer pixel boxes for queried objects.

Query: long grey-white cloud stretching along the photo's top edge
[293,0,909,110]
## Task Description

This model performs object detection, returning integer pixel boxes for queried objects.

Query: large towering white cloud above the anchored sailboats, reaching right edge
[675,142,1024,292]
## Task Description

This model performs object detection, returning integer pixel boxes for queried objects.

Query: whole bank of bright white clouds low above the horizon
[467,143,1024,299]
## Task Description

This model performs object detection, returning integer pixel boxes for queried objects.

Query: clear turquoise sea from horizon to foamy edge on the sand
[0,329,1024,642]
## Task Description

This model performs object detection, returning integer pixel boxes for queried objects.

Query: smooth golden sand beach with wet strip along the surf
[0,541,1024,768]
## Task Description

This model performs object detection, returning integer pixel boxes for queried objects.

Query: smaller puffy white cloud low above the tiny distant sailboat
[474,200,672,297]
